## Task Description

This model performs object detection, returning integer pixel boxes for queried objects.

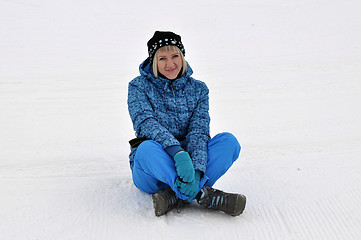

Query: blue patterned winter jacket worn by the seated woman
[128,59,210,172]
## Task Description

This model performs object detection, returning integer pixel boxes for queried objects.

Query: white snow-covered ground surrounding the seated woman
[0,0,361,240]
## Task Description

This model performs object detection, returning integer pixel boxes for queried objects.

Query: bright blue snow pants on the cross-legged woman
[132,133,241,200]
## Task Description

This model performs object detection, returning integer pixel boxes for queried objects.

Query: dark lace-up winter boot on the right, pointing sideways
[198,186,246,216]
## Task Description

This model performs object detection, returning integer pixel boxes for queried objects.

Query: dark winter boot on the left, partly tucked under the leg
[152,188,184,217]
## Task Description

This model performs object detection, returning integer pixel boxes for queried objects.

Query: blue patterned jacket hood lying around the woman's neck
[139,58,193,92]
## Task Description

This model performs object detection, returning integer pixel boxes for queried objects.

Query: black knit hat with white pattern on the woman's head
[147,31,186,61]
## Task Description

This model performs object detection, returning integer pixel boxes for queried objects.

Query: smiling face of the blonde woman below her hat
[155,47,183,80]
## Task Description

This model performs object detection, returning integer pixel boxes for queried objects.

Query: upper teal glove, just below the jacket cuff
[174,152,194,182]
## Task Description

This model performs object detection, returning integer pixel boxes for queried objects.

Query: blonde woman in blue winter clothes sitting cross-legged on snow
[128,31,246,216]
